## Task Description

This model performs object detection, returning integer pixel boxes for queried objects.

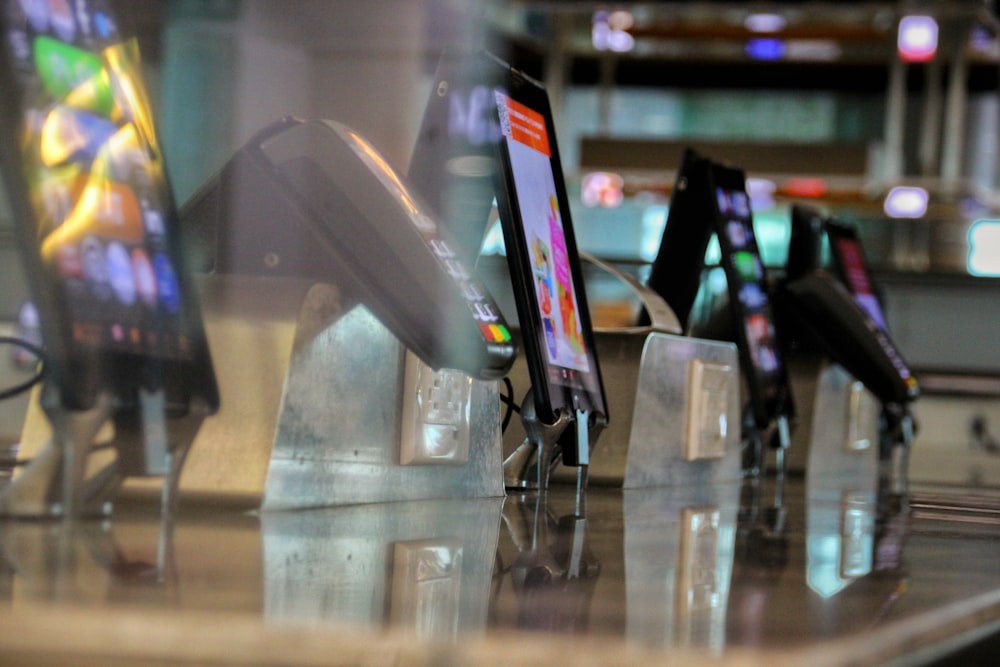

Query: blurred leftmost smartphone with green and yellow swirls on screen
[0,0,218,415]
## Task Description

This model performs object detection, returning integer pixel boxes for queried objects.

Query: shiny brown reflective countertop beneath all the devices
[0,475,1000,665]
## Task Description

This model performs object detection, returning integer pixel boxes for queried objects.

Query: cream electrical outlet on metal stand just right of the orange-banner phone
[684,359,739,461]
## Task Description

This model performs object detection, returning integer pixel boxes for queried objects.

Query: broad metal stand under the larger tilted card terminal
[113,275,503,510]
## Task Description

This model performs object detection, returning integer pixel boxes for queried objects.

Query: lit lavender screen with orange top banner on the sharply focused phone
[496,92,591,387]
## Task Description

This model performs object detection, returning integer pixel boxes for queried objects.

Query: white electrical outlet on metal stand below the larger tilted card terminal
[399,352,472,465]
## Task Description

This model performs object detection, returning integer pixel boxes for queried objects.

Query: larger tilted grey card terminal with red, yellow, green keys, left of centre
[184,118,515,380]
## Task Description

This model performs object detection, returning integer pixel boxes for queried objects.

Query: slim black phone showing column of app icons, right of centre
[709,163,794,428]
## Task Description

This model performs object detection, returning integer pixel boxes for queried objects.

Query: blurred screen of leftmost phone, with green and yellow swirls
[3,0,191,359]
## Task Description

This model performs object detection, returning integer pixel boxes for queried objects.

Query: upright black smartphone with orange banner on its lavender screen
[493,54,608,436]
